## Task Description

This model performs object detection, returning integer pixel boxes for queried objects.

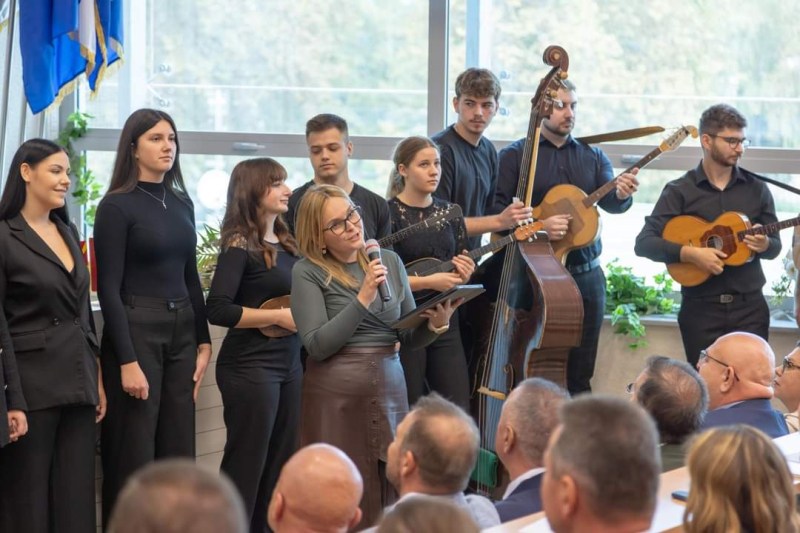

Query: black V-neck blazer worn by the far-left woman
[0,214,99,411]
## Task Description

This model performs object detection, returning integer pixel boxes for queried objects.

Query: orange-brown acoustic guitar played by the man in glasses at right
[662,211,800,287]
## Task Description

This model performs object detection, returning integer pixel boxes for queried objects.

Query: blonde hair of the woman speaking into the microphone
[295,185,369,289]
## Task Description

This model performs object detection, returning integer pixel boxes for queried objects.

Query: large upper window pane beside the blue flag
[82,0,428,136]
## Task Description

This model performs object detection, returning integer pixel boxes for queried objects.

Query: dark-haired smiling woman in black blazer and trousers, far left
[0,139,105,533]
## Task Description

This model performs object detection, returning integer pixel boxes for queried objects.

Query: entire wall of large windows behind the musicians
[78,0,800,292]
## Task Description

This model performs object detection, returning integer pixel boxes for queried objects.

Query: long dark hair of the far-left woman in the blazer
[0,139,69,225]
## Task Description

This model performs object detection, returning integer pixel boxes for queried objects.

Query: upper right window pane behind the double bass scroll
[482,0,800,148]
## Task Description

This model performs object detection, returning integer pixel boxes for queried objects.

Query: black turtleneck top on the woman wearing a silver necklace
[94,181,211,365]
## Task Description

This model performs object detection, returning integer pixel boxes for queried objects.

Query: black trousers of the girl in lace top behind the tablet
[400,317,469,412]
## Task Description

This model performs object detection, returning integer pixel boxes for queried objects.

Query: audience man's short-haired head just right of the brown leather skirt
[386,393,480,496]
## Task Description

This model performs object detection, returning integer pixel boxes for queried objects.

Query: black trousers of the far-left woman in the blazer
[0,405,97,533]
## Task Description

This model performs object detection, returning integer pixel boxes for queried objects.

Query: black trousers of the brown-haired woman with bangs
[217,352,303,533]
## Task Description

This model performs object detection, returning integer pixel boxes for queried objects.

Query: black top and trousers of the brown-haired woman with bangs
[207,242,303,533]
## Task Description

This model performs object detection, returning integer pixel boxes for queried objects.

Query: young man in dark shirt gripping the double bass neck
[432,68,531,248]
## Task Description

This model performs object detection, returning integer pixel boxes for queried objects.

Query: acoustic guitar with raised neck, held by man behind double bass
[533,126,698,264]
